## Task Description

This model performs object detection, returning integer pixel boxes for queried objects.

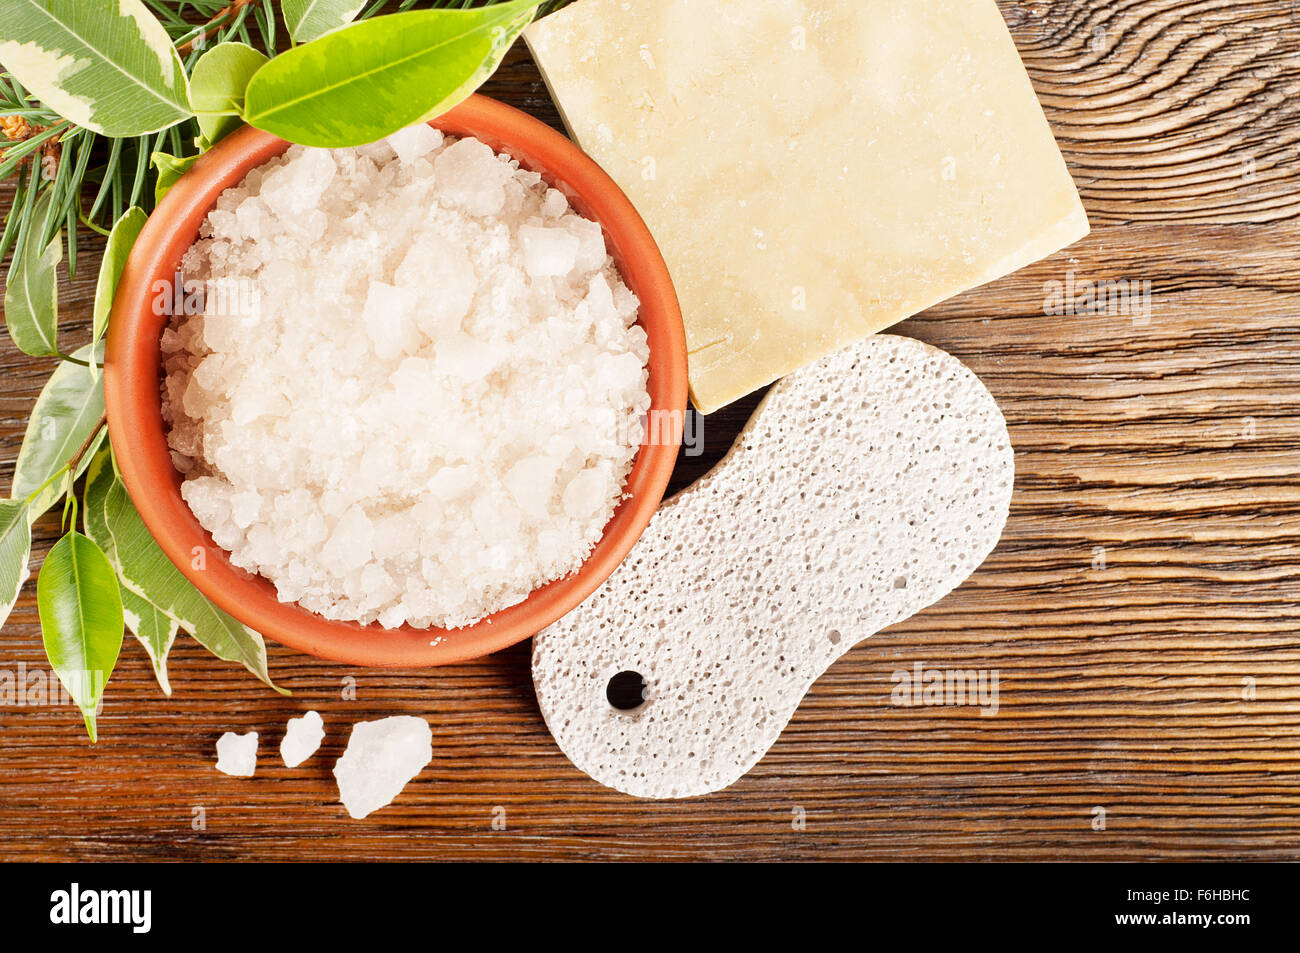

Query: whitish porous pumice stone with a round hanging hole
[533,335,1014,798]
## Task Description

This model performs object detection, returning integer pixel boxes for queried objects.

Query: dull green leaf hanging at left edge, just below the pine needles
[0,189,64,358]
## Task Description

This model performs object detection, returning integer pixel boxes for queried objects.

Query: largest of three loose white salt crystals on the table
[334,715,433,819]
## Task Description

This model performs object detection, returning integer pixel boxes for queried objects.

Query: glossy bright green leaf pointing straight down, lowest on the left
[36,530,122,742]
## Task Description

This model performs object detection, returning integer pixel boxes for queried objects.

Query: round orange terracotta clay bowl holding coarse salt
[104,95,686,666]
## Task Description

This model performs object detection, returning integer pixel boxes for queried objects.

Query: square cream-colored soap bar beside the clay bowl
[525,0,1088,412]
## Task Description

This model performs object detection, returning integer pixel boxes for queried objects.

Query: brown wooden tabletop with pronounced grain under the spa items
[0,0,1300,859]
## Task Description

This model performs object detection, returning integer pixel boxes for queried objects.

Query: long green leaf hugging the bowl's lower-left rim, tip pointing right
[85,451,289,694]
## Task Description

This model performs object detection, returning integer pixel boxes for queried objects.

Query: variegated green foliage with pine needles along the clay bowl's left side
[0,0,568,741]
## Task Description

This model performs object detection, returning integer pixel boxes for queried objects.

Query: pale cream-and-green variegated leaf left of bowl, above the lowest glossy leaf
[9,343,104,520]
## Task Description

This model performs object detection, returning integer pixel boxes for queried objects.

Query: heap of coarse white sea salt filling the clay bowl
[161,126,650,628]
